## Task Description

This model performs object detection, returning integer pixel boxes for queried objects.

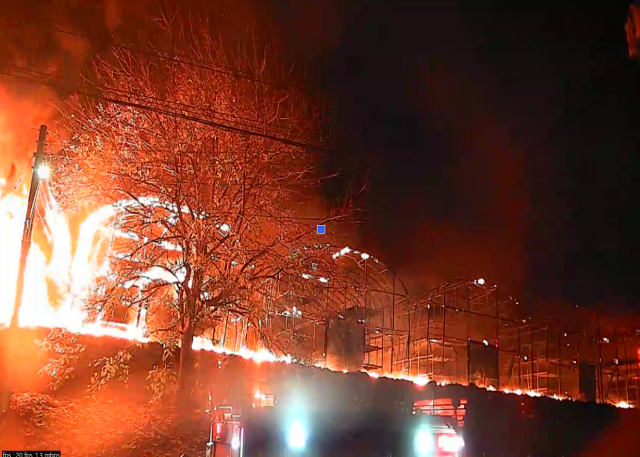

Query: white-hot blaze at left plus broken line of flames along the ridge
[0,166,632,408]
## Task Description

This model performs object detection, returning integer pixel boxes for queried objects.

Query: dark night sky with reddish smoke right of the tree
[3,0,640,306]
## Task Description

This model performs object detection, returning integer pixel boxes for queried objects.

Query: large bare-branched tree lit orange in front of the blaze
[56,21,356,387]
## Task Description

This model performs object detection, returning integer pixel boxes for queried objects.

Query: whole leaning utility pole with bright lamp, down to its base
[0,125,49,418]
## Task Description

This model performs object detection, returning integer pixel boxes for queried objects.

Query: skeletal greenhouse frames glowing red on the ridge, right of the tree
[210,248,640,405]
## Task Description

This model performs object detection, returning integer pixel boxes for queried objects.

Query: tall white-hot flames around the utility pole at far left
[0,182,117,337]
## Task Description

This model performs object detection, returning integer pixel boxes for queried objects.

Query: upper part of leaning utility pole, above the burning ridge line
[11,125,48,329]
